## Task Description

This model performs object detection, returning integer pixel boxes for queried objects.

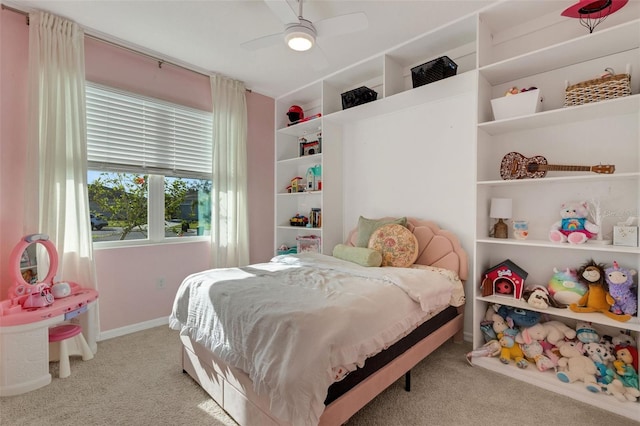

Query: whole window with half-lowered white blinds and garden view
[86,83,212,242]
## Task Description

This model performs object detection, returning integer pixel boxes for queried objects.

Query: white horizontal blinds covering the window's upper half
[86,82,212,179]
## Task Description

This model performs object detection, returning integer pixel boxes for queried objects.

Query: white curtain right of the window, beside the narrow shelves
[210,75,249,268]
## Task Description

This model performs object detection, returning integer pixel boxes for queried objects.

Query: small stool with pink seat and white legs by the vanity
[49,324,93,379]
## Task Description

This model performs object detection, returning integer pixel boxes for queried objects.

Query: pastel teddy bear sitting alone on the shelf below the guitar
[549,201,600,244]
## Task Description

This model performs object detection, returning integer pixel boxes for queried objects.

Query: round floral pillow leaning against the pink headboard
[369,224,418,268]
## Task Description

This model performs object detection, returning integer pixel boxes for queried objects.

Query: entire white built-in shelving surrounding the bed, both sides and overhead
[274,1,640,420]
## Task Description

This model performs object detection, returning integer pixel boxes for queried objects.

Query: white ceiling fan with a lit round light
[241,0,369,66]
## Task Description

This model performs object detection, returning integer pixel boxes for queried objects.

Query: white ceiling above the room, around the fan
[3,0,504,98]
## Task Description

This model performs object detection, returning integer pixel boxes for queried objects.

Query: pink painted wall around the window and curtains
[0,10,274,332]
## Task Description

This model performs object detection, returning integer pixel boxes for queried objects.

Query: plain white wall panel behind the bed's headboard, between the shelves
[343,92,476,336]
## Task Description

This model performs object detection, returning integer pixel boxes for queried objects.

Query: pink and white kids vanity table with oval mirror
[0,234,98,396]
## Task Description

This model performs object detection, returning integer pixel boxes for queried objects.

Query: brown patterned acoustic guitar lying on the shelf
[500,152,616,180]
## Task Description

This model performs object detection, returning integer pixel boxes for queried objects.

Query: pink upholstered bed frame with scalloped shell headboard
[180,218,469,426]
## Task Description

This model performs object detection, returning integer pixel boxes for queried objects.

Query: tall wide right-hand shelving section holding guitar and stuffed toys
[473,2,640,420]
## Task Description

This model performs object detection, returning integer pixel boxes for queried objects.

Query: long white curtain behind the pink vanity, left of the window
[25,12,97,288]
